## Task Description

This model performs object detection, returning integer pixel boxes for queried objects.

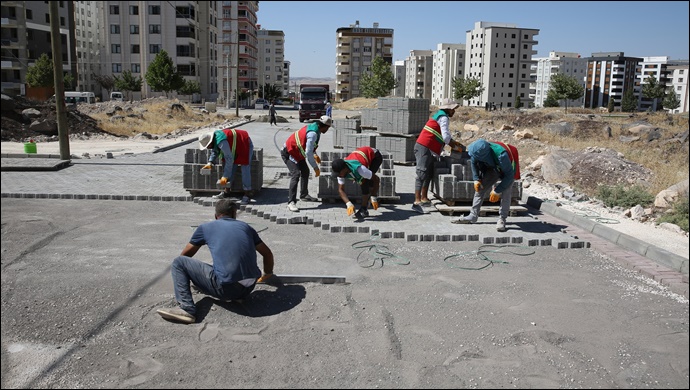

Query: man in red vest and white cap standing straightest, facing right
[412,99,465,214]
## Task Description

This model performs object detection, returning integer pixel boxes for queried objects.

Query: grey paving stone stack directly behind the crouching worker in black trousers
[318,149,400,202]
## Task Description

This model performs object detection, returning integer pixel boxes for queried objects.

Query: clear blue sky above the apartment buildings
[257,1,690,78]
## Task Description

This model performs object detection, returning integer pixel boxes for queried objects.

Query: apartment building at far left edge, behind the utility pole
[0,1,79,96]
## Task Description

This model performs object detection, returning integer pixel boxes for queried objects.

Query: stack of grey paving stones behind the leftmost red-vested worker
[182,148,264,195]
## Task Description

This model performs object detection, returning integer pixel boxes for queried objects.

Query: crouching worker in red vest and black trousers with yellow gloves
[331,146,383,220]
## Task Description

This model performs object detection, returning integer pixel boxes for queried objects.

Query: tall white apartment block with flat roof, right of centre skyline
[465,22,539,107]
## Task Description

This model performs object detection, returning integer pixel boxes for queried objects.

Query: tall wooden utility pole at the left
[48,1,70,160]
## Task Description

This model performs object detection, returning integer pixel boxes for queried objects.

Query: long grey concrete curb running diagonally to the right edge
[523,196,690,275]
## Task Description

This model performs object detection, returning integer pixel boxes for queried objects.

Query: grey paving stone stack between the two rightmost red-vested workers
[432,151,522,204]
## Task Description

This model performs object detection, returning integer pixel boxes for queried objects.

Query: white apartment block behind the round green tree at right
[531,51,587,107]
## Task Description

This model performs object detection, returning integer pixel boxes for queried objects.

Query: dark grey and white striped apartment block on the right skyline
[584,52,642,109]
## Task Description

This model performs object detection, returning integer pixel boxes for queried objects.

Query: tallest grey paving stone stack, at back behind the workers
[376,97,429,164]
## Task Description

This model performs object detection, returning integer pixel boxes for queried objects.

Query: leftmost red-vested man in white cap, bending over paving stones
[199,129,254,204]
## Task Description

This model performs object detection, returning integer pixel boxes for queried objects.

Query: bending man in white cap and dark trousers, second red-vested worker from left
[280,115,333,212]
